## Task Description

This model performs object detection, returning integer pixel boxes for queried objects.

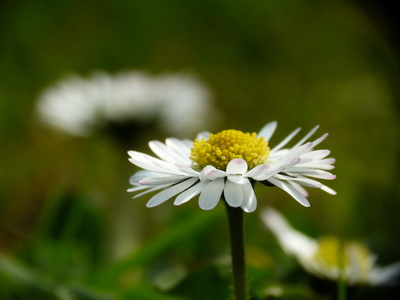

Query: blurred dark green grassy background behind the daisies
[0,0,400,300]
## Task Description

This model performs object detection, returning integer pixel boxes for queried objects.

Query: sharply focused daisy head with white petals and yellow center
[128,122,335,212]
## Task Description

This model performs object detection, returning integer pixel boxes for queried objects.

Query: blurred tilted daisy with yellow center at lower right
[261,208,400,285]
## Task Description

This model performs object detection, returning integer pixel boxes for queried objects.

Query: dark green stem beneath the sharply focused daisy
[226,204,249,300]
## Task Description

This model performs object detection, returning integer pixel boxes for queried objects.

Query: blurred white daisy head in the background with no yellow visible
[37,71,215,136]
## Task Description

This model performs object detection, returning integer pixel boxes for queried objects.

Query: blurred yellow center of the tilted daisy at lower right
[314,236,371,281]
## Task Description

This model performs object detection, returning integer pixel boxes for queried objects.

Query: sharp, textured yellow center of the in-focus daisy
[190,129,269,171]
